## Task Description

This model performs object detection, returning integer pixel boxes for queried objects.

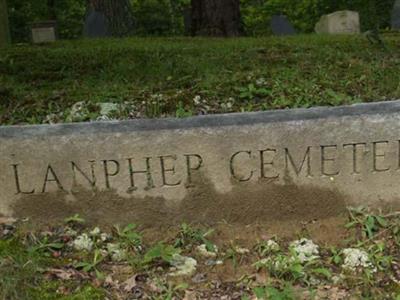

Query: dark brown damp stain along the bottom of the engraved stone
[13,173,346,227]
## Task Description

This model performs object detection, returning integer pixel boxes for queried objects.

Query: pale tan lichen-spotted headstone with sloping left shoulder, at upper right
[315,10,360,34]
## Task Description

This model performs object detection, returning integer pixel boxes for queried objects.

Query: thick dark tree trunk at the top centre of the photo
[191,0,241,37]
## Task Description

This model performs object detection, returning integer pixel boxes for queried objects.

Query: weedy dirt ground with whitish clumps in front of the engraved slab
[0,208,400,300]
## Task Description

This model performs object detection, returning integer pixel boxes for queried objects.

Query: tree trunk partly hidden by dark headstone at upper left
[88,0,134,36]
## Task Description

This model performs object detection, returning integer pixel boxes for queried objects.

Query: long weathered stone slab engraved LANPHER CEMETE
[0,101,400,225]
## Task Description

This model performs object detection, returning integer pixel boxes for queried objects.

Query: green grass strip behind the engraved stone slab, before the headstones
[0,34,400,125]
